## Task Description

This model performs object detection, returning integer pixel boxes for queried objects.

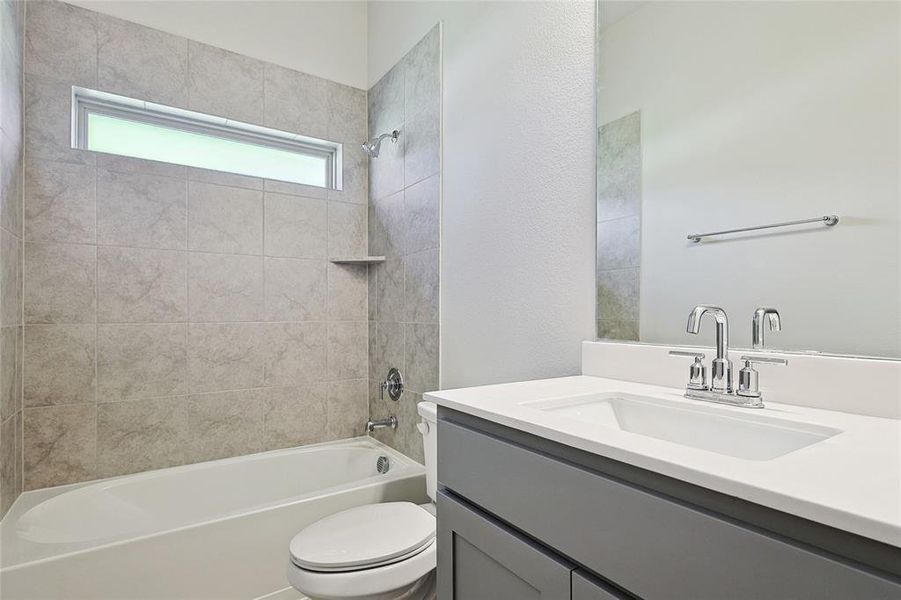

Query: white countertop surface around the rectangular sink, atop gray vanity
[424,375,901,547]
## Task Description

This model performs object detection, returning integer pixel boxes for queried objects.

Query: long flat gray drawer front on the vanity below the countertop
[438,420,901,600]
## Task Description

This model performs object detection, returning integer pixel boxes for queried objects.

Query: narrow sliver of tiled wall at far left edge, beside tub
[0,0,25,517]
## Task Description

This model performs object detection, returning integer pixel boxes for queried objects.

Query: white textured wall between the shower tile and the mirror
[368,2,596,387]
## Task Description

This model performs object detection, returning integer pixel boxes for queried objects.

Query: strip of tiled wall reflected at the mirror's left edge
[597,112,641,341]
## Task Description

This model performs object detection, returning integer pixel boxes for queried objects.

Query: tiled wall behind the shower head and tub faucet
[369,25,441,462]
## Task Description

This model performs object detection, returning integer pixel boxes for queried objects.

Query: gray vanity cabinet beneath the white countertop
[438,409,901,600]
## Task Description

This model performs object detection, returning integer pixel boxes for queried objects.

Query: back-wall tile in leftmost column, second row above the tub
[24,325,96,406]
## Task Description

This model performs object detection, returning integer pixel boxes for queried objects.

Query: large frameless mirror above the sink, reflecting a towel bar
[597,0,901,358]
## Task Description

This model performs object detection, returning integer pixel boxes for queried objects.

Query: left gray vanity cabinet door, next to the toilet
[438,492,572,600]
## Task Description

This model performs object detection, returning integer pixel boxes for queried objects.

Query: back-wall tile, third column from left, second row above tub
[188,323,264,392]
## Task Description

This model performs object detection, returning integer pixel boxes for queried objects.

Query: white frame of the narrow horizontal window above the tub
[72,86,343,190]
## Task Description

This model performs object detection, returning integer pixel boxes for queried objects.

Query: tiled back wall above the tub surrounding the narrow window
[22,1,368,489]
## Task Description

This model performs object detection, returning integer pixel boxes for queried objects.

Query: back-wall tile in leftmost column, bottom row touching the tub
[23,404,97,490]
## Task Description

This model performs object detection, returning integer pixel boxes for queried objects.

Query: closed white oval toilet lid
[291,502,435,571]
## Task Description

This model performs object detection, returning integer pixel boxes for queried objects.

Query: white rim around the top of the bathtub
[0,436,425,575]
